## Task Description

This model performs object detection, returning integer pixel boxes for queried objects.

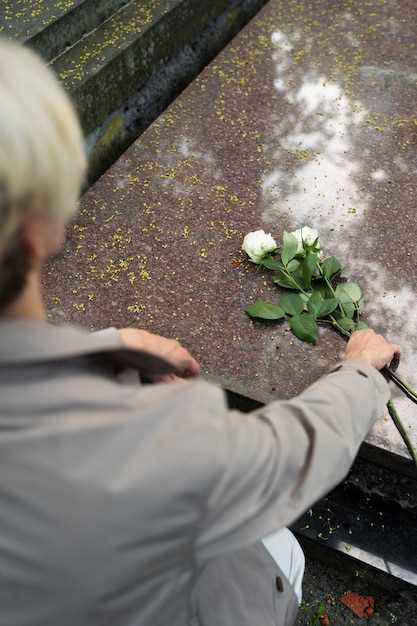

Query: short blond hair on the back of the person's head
[0,38,87,307]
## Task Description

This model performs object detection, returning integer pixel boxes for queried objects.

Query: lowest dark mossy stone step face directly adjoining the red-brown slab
[82,0,266,182]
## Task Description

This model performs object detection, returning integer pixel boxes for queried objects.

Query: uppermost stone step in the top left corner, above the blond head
[0,0,128,61]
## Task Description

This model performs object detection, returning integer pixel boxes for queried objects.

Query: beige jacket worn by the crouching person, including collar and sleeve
[0,322,389,626]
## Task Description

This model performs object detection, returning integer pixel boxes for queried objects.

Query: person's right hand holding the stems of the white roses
[344,330,401,370]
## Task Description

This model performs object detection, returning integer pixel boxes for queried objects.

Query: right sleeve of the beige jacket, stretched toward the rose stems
[195,361,389,565]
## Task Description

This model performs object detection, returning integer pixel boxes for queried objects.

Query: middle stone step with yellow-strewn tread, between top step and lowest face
[52,0,260,138]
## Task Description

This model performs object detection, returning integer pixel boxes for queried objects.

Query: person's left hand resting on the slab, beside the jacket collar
[119,328,200,382]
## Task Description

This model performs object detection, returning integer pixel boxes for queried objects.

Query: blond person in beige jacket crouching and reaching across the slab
[0,41,399,626]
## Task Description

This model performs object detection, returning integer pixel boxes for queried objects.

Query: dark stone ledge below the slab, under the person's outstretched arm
[293,460,417,590]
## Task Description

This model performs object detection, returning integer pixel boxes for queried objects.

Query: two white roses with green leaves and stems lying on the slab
[242,226,417,465]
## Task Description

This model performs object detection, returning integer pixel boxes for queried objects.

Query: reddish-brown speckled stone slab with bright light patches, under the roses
[45,0,417,466]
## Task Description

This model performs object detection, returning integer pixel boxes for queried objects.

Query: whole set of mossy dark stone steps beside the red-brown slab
[0,0,266,182]
